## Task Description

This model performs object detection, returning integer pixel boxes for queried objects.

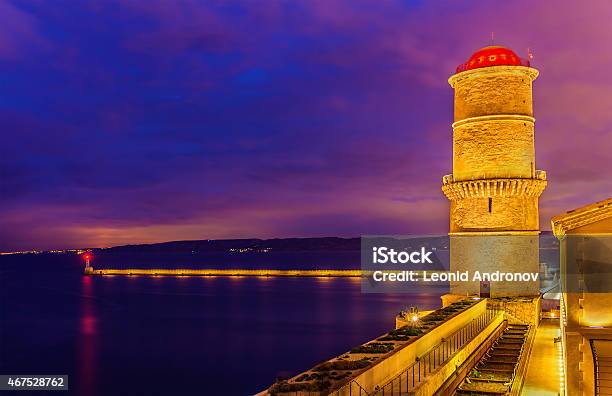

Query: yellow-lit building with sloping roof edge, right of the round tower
[552,198,612,396]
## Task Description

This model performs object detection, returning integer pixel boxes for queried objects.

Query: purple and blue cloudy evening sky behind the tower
[0,0,612,251]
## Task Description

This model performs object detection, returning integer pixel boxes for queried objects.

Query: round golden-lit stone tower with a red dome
[442,46,546,297]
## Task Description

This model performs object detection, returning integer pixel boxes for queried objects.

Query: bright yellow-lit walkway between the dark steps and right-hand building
[522,319,563,396]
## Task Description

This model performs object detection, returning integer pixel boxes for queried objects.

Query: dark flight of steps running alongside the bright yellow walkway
[455,324,529,396]
